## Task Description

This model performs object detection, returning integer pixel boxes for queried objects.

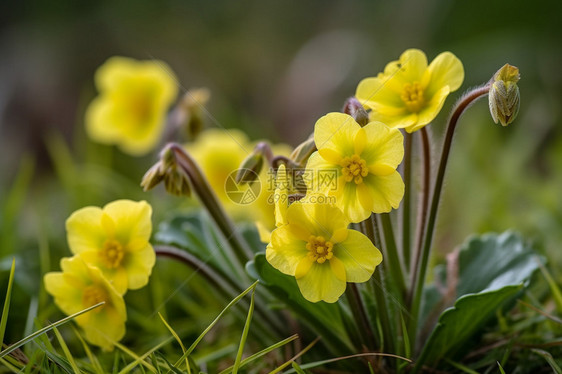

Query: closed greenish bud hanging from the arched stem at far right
[488,64,520,126]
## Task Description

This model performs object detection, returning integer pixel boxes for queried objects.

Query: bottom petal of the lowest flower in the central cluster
[297,263,346,303]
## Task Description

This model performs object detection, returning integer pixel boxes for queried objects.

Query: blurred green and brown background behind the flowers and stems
[0,0,562,344]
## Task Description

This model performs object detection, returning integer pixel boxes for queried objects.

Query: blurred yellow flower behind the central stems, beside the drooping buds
[186,129,290,230]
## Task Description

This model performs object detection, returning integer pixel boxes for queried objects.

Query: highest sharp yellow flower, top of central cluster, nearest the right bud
[355,49,464,133]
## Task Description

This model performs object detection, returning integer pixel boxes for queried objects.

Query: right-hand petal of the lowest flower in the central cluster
[334,230,382,283]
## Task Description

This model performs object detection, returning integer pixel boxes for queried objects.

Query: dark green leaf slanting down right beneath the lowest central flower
[246,253,353,353]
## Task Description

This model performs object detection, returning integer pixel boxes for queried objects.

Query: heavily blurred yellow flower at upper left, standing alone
[86,57,178,155]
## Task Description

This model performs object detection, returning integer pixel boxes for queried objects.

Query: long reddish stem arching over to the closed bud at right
[409,84,490,348]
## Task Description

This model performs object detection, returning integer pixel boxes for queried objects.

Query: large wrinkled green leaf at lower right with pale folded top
[416,232,540,370]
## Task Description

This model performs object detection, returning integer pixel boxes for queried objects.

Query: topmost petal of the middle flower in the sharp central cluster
[314,113,361,155]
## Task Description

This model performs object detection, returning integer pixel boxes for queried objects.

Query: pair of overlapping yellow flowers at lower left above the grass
[44,200,156,350]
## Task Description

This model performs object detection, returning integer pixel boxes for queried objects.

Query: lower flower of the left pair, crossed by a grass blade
[44,256,127,350]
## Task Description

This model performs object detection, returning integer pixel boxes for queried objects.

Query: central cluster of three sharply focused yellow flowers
[266,49,464,302]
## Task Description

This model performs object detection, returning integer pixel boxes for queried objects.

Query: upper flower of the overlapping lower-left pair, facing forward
[66,200,156,295]
